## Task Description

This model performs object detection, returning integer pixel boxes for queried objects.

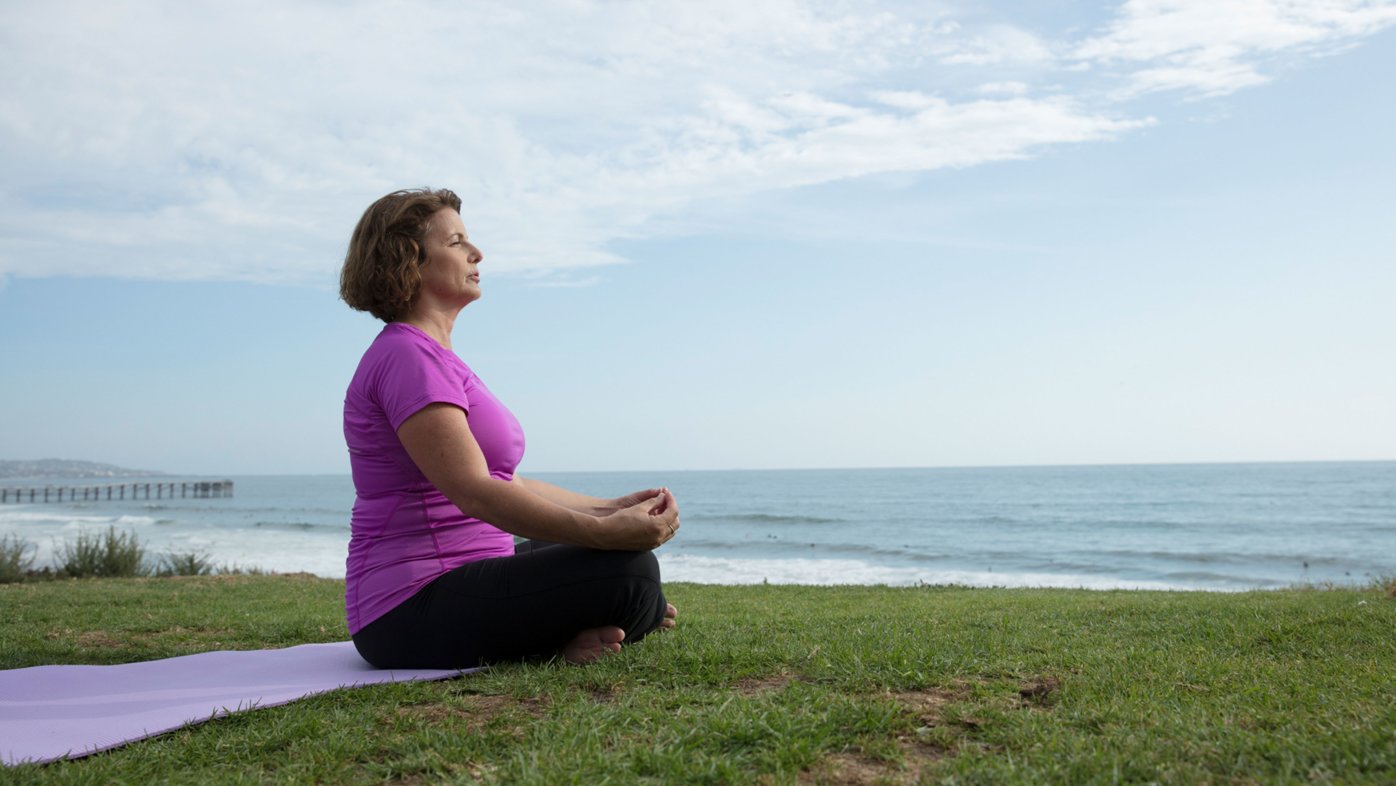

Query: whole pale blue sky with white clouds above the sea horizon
[0,0,1396,475]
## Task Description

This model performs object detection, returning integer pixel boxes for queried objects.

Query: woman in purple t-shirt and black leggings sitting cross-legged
[339,188,678,669]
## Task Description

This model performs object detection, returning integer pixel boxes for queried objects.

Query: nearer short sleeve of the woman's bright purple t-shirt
[369,335,470,431]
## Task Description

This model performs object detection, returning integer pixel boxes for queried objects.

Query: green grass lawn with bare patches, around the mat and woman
[0,577,1396,786]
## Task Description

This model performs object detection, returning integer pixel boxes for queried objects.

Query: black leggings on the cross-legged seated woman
[353,540,667,669]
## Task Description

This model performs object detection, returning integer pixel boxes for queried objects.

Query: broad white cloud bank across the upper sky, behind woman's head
[0,0,1390,283]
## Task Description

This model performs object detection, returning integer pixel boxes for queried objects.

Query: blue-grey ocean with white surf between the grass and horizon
[0,462,1396,591]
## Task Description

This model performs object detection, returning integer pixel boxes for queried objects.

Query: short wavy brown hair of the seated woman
[339,188,461,322]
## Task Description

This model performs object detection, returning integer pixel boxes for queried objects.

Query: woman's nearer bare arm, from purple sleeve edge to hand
[398,403,678,551]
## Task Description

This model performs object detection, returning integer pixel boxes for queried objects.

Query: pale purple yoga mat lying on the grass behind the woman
[0,641,479,765]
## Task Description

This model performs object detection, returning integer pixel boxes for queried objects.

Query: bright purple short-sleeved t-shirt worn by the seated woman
[345,322,524,634]
